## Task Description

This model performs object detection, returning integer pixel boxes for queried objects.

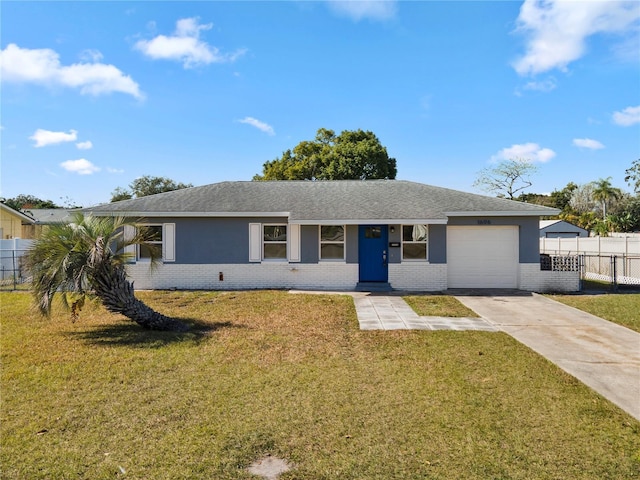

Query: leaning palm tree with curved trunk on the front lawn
[25,213,188,331]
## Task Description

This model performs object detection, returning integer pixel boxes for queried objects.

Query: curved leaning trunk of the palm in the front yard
[92,265,189,332]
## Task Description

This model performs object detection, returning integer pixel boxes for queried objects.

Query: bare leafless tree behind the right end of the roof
[473,158,538,200]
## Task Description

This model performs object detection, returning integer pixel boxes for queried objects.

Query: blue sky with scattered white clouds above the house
[0,0,640,206]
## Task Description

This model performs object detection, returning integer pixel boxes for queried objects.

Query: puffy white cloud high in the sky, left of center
[135,17,245,68]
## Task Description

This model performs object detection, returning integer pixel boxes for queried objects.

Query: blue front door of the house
[358,225,389,282]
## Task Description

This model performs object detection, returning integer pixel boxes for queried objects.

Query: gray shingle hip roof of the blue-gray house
[86,180,559,223]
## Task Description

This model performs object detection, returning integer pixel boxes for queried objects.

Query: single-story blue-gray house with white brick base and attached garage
[85,180,579,291]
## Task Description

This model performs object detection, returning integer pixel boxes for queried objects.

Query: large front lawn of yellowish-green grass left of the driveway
[0,291,640,480]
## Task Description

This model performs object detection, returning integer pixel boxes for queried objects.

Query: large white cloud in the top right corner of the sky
[513,0,640,75]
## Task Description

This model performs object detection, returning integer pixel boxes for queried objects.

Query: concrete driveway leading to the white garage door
[448,290,640,420]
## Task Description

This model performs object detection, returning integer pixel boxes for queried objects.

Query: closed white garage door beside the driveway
[447,225,519,288]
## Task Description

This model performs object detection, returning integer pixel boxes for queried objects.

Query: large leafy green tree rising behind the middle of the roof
[253,128,397,180]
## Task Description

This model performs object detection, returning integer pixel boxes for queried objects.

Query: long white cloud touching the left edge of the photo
[0,43,143,98]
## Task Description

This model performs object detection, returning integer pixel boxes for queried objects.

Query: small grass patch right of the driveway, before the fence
[549,293,640,332]
